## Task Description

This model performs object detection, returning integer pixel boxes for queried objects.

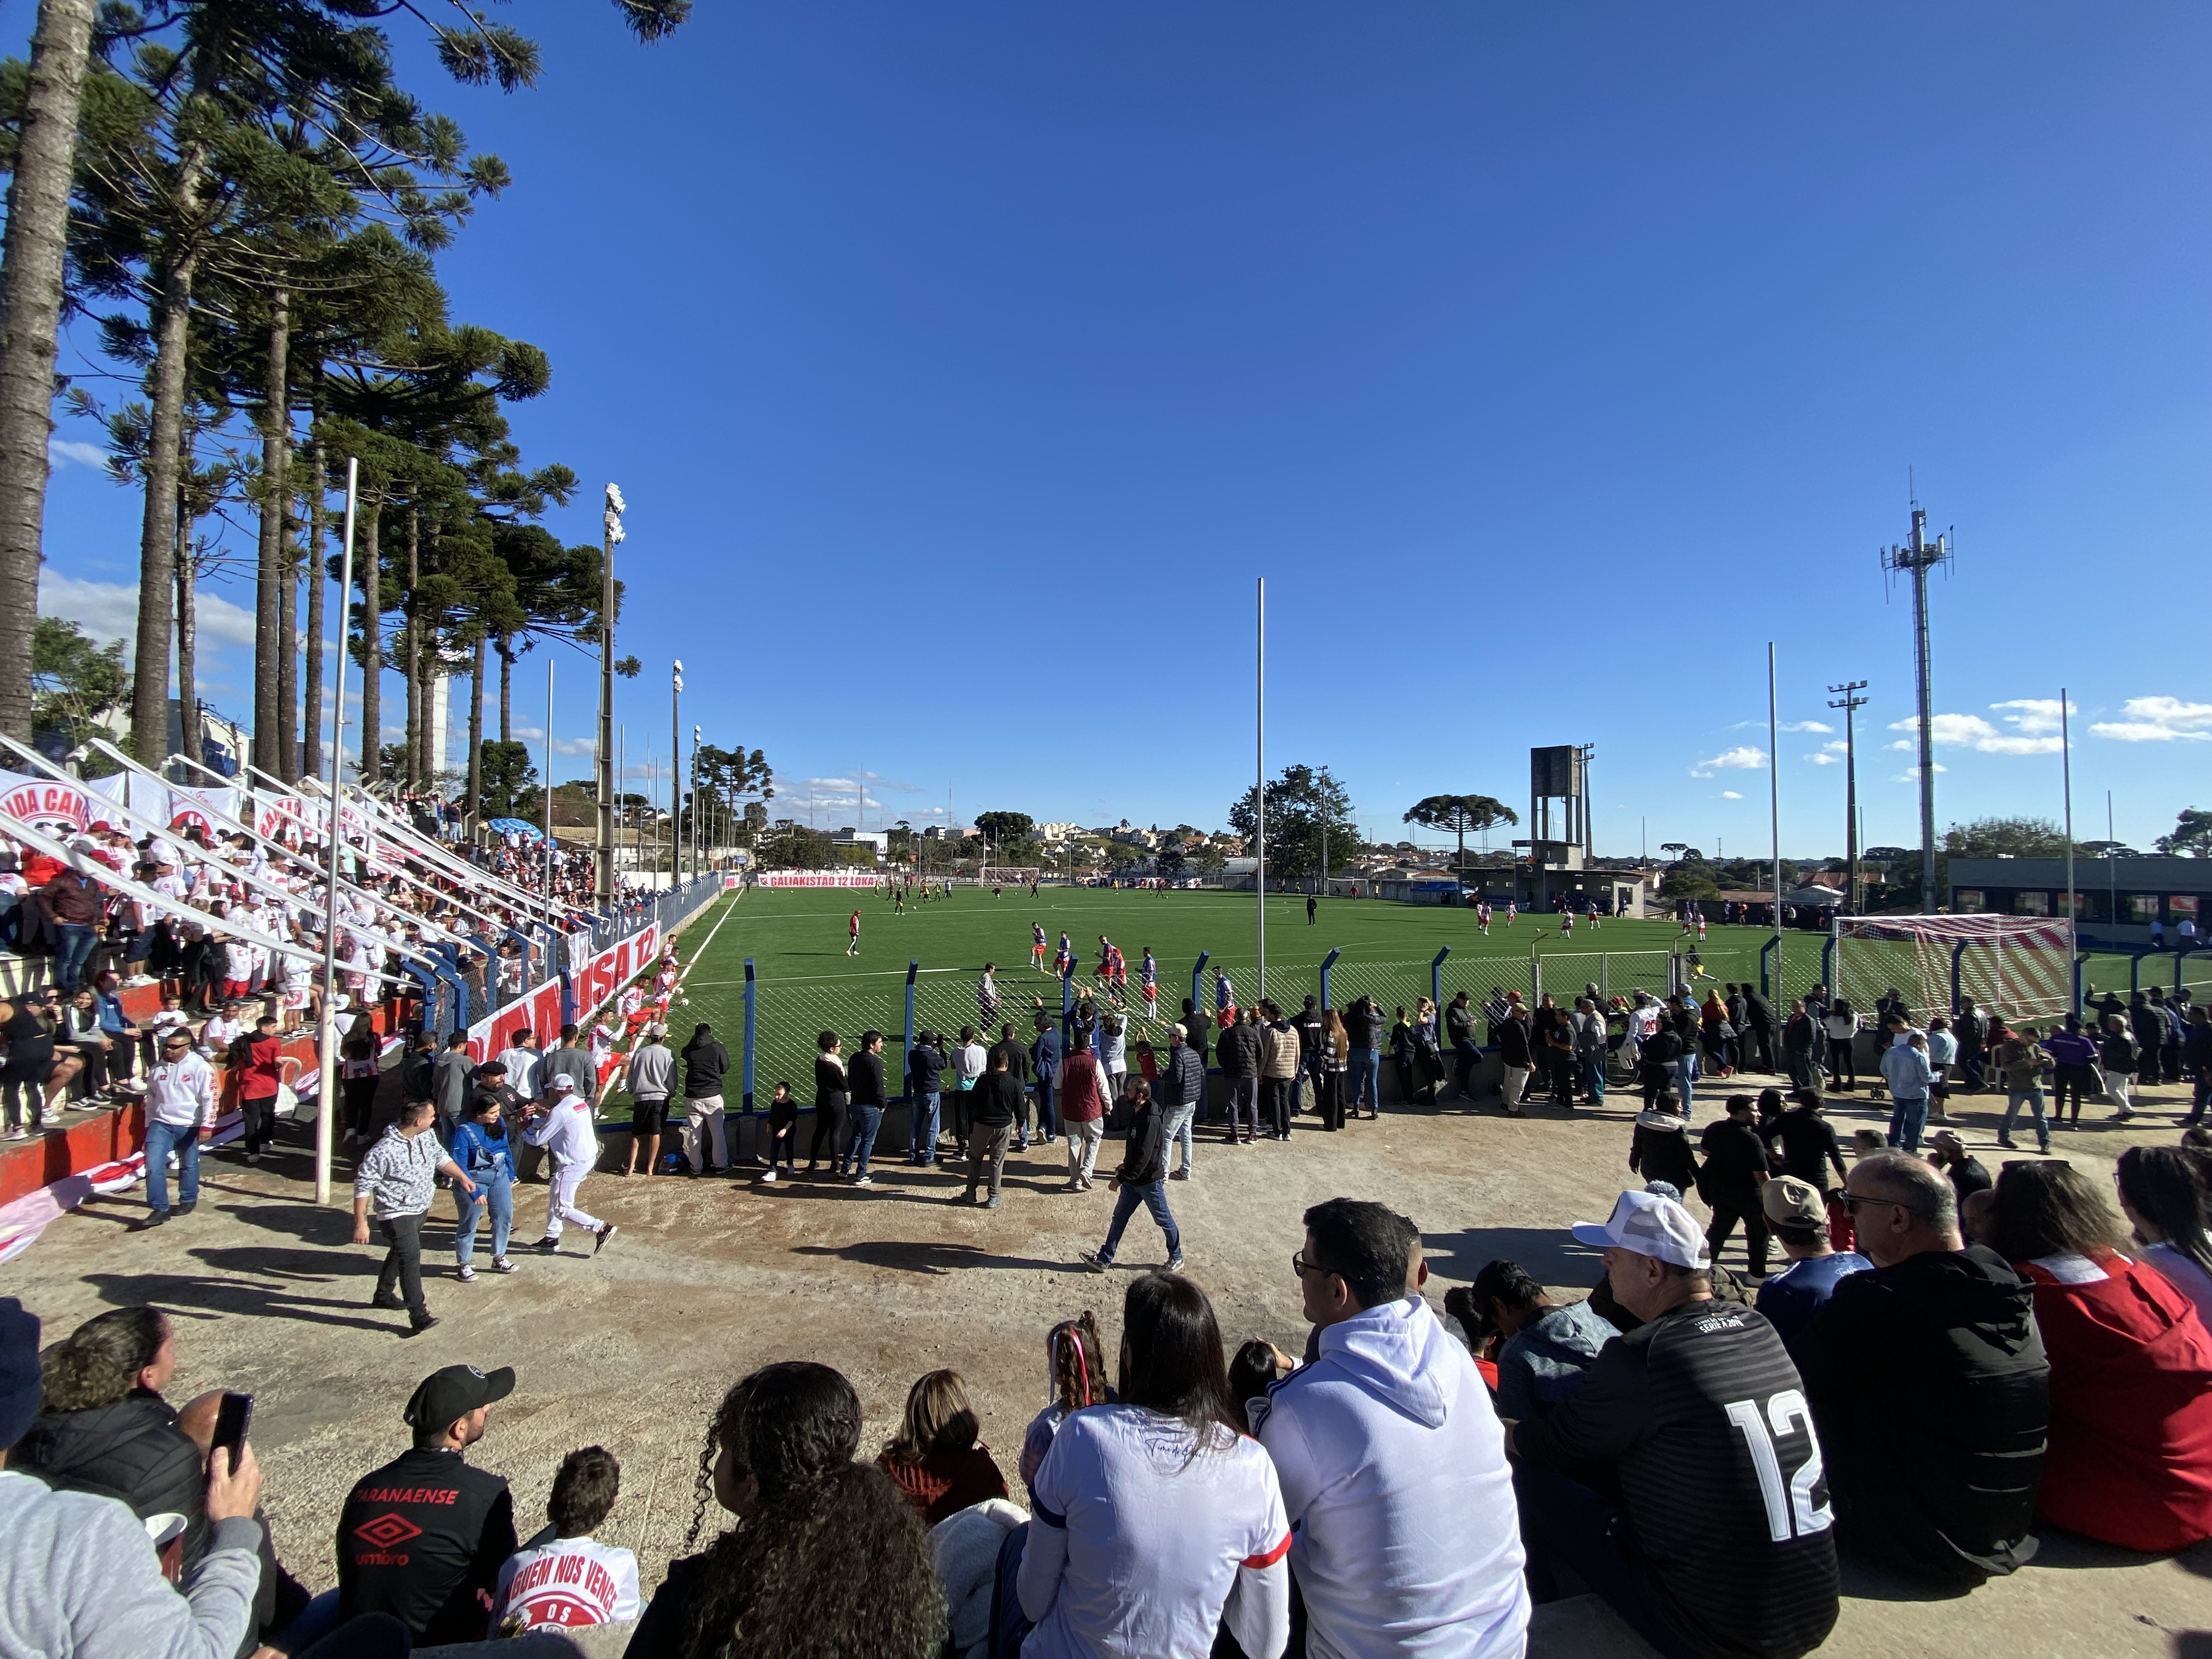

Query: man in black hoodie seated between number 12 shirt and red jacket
[1792,1153,2051,1586]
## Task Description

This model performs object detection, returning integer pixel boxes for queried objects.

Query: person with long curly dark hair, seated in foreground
[626,1361,945,1659]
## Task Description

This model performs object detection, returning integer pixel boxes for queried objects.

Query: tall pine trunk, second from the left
[131,148,206,768]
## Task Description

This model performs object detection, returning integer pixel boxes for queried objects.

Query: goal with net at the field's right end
[1831,916,2073,1035]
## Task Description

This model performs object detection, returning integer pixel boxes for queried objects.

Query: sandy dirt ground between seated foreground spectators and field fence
[4,1070,2212,1659]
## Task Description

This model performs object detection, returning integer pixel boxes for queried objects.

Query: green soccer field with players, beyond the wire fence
[673,887,1778,1104]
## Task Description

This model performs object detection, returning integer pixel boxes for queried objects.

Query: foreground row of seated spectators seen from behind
[0,1130,2212,1659]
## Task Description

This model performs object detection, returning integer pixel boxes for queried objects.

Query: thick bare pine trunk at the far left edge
[0,0,99,743]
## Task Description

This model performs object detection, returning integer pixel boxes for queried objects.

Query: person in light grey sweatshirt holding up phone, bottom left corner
[0,1296,294,1659]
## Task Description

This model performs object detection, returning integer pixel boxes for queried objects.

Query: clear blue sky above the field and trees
[26,0,2212,854]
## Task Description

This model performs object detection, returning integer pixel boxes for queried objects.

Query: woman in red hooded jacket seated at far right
[1989,1164,2212,1550]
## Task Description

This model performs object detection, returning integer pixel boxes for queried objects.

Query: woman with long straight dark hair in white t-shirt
[1015,1274,1290,1659]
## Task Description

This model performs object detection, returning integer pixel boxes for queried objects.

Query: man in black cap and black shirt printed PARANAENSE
[338,1365,515,1648]
